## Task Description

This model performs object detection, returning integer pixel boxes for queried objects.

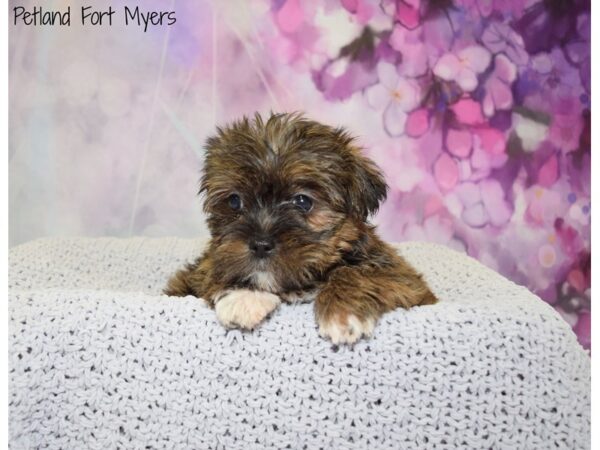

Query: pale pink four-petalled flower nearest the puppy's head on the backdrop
[366,62,421,136]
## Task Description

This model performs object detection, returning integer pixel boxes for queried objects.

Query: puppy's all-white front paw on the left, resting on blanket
[215,289,281,330]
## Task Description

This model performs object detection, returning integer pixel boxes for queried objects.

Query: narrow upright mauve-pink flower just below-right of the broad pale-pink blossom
[483,54,517,117]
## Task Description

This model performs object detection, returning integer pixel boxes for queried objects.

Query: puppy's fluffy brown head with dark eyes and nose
[201,114,386,293]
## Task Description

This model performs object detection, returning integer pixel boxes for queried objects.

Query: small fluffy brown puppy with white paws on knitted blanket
[165,114,436,343]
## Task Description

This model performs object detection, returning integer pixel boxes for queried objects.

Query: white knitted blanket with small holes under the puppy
[9,238,590,450]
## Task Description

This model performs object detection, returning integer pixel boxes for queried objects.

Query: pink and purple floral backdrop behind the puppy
[9,0,591,348]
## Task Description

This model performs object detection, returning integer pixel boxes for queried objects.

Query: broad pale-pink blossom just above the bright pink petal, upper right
[433,45,491,92]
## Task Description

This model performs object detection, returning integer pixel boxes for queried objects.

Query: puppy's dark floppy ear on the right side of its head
[348,149,388,221]
